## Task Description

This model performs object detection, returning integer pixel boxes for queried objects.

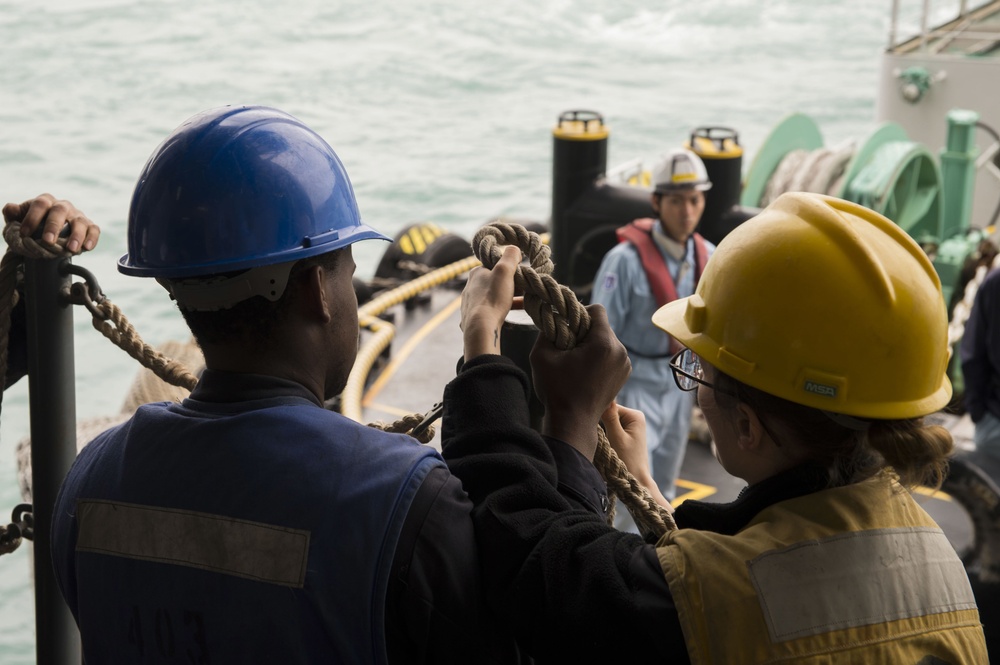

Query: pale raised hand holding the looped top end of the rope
[461,245,521,361]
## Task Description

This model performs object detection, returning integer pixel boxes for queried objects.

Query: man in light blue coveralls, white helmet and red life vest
[593,149,715,500]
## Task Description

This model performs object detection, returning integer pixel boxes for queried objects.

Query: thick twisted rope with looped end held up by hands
[472,222,677,536]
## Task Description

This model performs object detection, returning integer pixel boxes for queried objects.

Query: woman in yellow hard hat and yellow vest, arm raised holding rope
[444,193,988,665]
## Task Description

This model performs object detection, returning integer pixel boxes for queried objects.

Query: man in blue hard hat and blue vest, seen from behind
[52,106,517,665]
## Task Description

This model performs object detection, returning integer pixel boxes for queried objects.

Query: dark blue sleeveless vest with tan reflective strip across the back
[53,397,444,665]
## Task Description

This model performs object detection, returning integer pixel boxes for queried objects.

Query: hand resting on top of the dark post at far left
[3,194,101,254]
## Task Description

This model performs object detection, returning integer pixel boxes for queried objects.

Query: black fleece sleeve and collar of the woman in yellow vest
[442,356,827,663]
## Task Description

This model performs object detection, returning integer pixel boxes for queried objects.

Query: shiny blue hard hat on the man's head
[118,106,391,279]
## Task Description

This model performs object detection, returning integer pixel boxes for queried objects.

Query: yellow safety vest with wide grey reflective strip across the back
[657,474,988,665]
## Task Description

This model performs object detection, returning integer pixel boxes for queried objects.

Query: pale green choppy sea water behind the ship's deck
[0,0,955,665]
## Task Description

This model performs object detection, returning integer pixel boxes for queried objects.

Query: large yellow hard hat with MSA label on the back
[653,192,951,419]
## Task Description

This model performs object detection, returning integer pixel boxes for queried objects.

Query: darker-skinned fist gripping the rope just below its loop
[531,305,632,461]
